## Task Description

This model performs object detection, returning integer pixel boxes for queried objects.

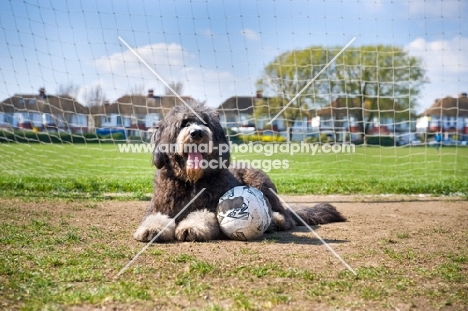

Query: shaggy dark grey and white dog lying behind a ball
[134,104,345,242]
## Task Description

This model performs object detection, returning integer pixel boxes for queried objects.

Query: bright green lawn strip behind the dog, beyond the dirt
[0,144,468,199]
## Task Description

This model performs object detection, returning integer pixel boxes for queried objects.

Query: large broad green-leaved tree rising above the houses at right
[255,45,425,138]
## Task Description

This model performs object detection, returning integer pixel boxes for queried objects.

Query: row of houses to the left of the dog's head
[0,88,193,140]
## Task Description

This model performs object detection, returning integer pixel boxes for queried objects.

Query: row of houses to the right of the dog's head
[218,93,468,142]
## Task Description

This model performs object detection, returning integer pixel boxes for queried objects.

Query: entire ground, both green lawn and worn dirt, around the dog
[0,144,468,311]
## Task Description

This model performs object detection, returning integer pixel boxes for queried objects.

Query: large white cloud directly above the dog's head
[95,43,243,107]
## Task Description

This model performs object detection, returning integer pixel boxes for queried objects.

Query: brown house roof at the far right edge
[422,94,468,117]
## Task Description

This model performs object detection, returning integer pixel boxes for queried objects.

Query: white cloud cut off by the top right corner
[405,0,467,17]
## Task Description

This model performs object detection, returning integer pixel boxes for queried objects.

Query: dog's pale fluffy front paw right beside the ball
[175,210,219,242]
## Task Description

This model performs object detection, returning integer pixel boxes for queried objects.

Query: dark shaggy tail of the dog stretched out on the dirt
[291,203,346,226]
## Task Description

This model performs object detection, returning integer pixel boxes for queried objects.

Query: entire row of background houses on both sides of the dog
[0,88,468,141]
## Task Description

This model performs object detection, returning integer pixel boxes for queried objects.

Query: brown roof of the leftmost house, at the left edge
[0,94,89,114]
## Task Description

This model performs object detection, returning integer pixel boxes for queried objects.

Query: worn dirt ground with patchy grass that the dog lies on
[0,196,468,310]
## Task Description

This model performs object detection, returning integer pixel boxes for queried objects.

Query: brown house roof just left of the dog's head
[91,95,194,115]
